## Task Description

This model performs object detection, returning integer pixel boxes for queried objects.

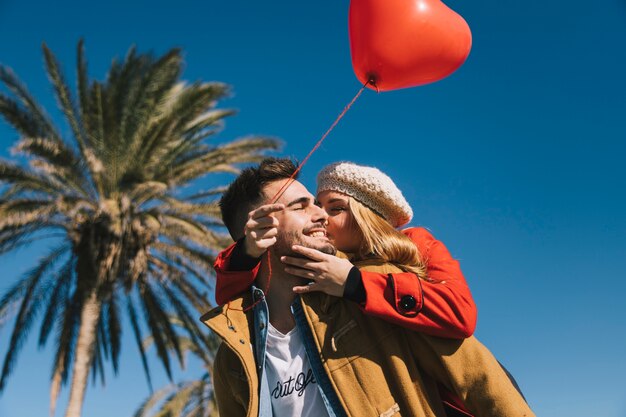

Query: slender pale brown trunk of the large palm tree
[65,291,102,417]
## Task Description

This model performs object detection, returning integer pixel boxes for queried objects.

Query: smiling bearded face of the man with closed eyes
[264,180,336,256]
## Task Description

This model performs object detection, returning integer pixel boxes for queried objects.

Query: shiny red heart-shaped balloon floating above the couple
[349,0,472,91]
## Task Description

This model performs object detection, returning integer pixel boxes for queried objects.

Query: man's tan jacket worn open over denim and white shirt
[202,263,534,417]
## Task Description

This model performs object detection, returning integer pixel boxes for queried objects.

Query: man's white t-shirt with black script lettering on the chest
[265,324,328,417]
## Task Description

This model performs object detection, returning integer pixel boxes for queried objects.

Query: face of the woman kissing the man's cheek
[317,191,362,253]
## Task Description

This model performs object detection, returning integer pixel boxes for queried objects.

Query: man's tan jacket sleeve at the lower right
[408,333,534,417]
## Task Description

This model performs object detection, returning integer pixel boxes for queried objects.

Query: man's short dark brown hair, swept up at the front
[220,158,298,240]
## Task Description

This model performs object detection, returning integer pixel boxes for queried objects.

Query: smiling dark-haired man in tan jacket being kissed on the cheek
[202,159,533,417]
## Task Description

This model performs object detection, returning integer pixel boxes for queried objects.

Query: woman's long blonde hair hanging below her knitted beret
[348,197,428,280]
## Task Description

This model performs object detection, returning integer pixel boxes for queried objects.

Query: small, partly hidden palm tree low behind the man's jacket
[134,318,220,417]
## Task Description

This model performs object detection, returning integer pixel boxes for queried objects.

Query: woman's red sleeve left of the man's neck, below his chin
[213,243,260,305]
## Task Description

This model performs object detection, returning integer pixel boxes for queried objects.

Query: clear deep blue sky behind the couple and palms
[0,0,626,417]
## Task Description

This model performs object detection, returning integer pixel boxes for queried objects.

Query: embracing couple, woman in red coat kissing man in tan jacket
[202,158,534,417]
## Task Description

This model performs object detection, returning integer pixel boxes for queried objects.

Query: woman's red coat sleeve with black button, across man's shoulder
[361,228,476,339]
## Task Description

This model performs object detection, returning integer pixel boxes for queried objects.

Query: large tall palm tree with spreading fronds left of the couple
[0,41,277,417]
